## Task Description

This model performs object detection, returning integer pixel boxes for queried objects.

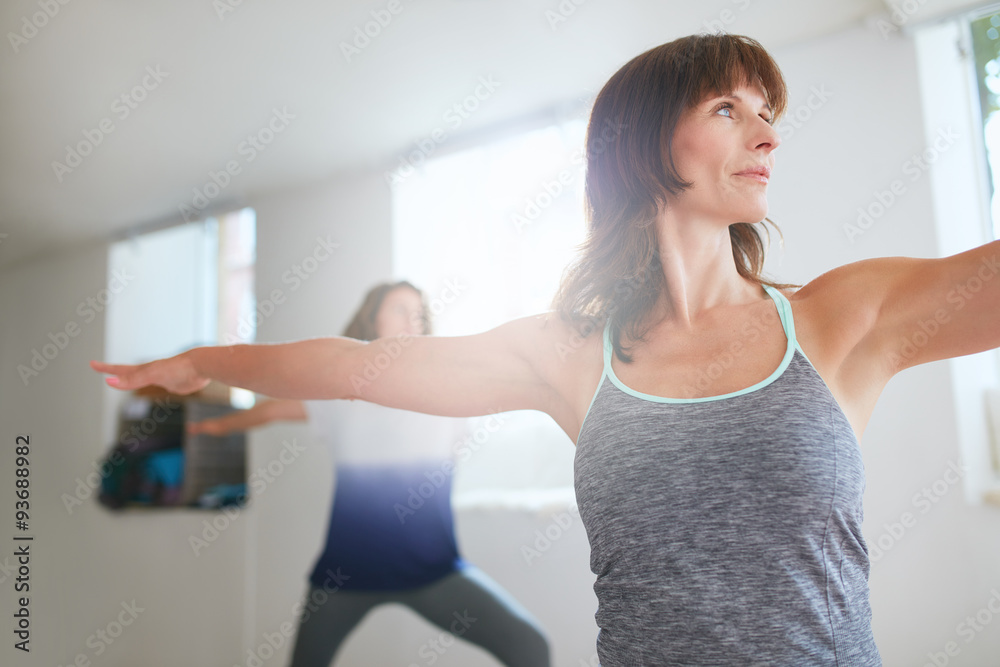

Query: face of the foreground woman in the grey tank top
[668,81,781,226]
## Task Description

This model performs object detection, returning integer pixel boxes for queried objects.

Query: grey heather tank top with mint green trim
[575,287,882,667]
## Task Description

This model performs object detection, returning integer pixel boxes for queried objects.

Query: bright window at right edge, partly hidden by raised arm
[912,11,1000,504]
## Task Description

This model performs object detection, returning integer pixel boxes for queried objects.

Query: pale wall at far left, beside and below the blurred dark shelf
[0,235,245,667]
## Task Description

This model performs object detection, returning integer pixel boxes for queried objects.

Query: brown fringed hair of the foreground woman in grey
[553,33,793,362]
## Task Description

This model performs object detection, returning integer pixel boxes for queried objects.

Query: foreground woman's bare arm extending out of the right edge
[801,241,1000,380]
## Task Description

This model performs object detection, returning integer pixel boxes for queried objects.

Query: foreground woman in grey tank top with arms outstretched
[92,34,1000,667]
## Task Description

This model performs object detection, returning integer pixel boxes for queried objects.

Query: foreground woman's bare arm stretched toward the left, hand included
[91,315,580,427]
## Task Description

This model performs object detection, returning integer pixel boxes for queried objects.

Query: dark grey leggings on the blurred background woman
[291,565,549,667]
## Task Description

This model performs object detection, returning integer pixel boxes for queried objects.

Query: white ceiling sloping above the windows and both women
[0,0,957,264]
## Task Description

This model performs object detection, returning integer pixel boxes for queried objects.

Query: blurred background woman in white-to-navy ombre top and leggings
[188,281,549,667]
